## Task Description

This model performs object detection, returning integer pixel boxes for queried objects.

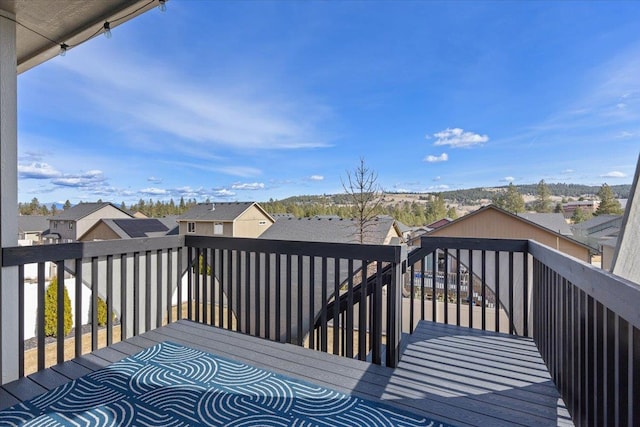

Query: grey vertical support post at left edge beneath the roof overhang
[0,10,21,384]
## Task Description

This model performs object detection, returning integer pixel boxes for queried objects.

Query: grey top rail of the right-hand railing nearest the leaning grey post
[529,241,640,328]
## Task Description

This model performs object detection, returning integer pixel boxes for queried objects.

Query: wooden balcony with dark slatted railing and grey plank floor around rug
[0,236,640,425]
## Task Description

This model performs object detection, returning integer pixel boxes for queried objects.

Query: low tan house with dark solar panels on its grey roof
[78,217,178,242]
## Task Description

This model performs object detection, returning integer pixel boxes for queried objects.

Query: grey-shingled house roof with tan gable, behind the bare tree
[260,216,402,245]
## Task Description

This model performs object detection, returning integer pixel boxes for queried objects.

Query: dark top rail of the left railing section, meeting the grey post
[2,235,184,267]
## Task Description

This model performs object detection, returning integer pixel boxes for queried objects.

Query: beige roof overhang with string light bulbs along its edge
[0,0,159,74]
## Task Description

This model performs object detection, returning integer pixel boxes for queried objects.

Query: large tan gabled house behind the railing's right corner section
[427,205,593,262]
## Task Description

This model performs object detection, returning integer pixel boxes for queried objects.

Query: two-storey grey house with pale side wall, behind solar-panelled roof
[48,203,131,243]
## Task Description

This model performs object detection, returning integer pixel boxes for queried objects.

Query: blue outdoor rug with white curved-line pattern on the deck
[0,342,452,427]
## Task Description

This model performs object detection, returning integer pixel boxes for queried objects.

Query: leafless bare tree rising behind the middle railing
[341,157,384,243]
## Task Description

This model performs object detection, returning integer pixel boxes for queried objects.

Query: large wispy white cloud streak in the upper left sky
[52,49,329,151]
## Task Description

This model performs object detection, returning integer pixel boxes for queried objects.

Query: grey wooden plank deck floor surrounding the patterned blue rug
[0,320,572,426]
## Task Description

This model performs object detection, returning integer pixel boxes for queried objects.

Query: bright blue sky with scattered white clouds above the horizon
[18,0,640,204]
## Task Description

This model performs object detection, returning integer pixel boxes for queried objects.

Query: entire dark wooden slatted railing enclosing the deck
[2,236,640,425]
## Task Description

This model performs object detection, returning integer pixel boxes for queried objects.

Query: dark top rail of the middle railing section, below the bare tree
[185,235,407,263]
